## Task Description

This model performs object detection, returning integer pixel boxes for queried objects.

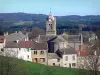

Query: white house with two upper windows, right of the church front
[62,48,77,68]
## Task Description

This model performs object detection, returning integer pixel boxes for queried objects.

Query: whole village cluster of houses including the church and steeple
[0,12,95,68]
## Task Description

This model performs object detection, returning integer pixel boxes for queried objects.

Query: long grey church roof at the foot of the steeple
[35,34,80,42]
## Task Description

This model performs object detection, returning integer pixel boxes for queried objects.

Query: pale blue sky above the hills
[0,0,100,16]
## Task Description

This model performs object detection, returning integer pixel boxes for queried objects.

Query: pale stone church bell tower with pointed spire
[46,11,56,35]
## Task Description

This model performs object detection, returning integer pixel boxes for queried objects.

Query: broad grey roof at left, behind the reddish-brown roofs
[6,32,28,41]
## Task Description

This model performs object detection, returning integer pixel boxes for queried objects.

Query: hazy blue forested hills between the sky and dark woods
[0,13,100,27]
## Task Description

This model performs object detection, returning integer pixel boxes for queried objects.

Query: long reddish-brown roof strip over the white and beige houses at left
[5,41,48,50]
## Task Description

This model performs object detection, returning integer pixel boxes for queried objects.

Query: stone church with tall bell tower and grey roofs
[34,12,83,57]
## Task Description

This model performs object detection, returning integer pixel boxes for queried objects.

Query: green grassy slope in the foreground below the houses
[0,56,88,75]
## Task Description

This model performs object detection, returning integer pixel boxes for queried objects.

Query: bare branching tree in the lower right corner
[80,32,100,75]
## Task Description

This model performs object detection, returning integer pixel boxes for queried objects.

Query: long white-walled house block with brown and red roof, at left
[3,40,32,61]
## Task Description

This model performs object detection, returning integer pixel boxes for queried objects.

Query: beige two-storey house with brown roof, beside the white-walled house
[31,41,48,64]
